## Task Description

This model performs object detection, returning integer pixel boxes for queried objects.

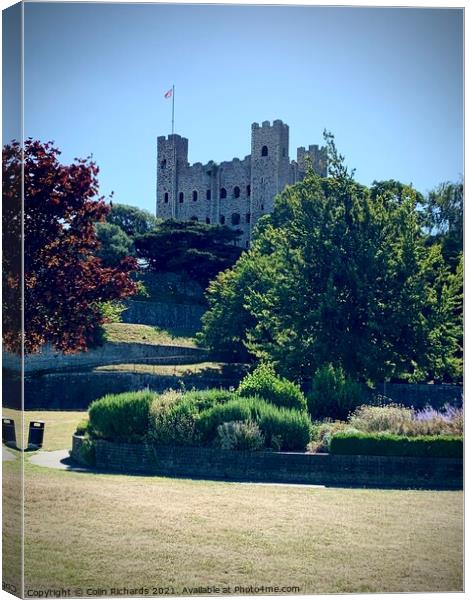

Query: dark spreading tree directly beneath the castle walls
[135,219,241,287]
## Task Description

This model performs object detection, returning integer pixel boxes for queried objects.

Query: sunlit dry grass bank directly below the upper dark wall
[105,323,196,347]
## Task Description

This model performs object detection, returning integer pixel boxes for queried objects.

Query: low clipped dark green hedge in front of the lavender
[330,432,463,458]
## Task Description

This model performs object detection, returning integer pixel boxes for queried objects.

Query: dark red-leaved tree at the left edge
[3,139,137,352]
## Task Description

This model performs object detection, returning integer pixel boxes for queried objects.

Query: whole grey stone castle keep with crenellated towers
[157,120,327,247]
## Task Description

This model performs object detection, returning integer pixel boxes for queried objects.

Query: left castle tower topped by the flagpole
[157,134,188,219]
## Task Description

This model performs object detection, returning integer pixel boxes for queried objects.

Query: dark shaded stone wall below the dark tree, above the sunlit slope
[122,300,205,335]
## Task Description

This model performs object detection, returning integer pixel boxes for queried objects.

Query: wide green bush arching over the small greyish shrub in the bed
[196,397,311,451]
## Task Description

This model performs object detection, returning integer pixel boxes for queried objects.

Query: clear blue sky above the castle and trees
[9,3,463,211]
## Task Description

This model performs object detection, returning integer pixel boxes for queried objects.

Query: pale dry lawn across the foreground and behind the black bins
[0,413,463,594]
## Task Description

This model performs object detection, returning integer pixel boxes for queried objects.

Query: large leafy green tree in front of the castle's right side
[200,134,457,382]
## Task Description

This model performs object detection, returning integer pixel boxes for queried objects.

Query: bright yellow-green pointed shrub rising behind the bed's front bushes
[238,363,307,410]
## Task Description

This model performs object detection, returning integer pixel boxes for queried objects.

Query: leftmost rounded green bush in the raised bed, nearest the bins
[88,390,155,443]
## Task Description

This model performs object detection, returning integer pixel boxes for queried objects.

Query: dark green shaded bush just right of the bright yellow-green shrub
[308,364,367,420]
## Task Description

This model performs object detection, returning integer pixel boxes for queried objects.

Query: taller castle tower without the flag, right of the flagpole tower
[251,120,291,230]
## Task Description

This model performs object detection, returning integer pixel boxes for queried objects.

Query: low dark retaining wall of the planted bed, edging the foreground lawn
[73,436,463,489]
